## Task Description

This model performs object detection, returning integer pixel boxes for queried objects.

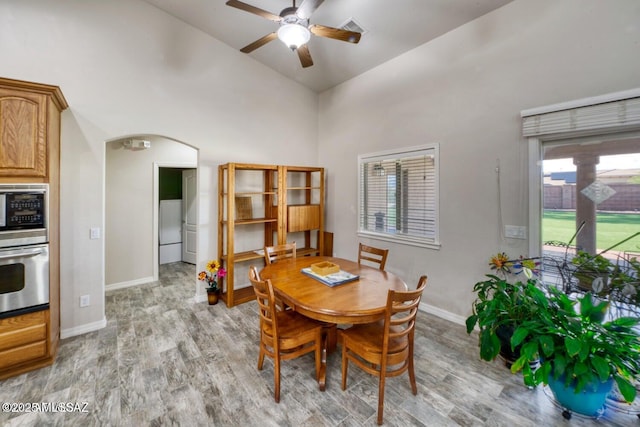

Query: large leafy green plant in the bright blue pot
[511,288,640,416]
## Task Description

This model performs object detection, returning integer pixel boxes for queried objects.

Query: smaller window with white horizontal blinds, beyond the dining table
[358,146,439,246]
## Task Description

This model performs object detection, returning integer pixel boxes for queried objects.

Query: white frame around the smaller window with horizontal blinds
[357,143,441,249]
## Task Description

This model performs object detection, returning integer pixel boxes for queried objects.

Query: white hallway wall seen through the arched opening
[105,135,198,288]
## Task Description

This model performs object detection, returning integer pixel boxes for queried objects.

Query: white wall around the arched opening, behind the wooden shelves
[0,0,318,336]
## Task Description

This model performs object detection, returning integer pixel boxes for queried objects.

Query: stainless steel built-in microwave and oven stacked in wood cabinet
[0,184,49,318]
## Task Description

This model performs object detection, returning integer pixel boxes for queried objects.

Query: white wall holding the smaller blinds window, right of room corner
[319,0,640,321]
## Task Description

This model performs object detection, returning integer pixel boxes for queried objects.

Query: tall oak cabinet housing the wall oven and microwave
[0,78,68,379]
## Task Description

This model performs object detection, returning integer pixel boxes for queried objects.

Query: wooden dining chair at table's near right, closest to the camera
[338,276,427,424]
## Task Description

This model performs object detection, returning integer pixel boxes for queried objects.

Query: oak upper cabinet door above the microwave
[0,87,47,178]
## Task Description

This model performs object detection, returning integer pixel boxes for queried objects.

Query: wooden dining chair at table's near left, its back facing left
[249,266,323,402]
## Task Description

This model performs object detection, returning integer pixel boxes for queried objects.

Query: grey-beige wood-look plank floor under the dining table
[0,263,640,427]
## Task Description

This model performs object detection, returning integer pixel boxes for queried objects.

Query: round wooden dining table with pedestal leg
[260,256,407,390]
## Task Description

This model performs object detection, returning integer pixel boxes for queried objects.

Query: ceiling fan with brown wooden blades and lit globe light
[227,0,360,68]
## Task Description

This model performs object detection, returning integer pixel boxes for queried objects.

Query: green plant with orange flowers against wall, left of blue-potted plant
[466,252,546,366]
